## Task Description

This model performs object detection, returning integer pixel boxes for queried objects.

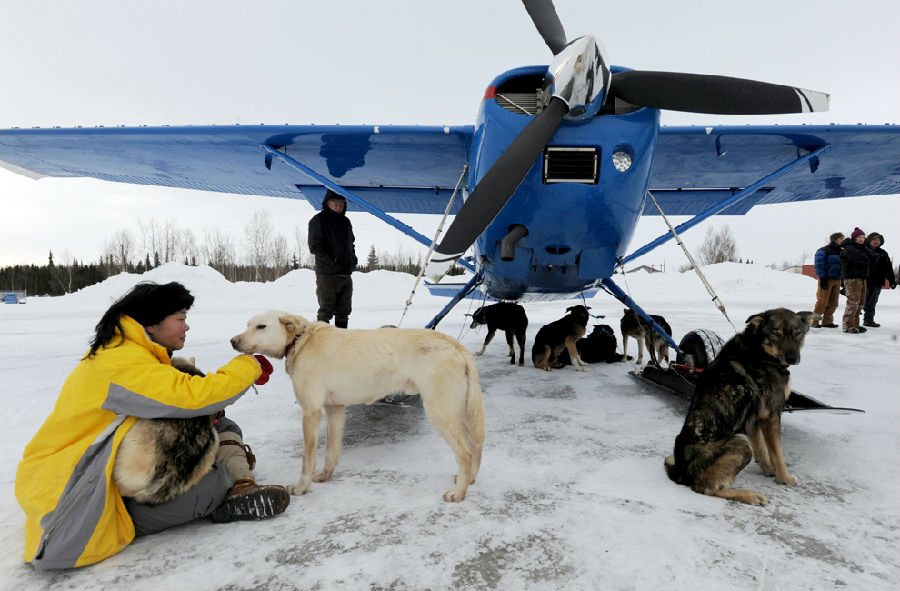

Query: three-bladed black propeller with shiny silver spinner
[429,0,828,274]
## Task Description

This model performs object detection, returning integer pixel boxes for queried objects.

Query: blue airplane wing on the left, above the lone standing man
[0,125,474,214]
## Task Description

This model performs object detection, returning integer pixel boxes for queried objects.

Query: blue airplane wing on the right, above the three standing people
[643,125,900,215]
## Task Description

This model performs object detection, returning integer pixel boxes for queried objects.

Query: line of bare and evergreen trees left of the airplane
[0,211,463,296]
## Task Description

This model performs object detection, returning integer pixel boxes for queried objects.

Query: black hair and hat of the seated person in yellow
[85,281,194,358]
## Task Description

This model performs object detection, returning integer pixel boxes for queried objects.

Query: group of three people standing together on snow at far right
[812,228,897,334]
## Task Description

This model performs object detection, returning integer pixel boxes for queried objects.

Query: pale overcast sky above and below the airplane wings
[0,0,900,265]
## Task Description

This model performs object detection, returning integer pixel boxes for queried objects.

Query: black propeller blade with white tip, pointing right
[610,71,829,115]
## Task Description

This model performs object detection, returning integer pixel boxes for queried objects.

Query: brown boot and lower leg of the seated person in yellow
[210,432,291,523]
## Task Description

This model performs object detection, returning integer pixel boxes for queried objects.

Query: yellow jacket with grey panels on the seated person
[16,316,262,569]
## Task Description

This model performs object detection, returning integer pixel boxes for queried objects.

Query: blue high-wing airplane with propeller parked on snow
[0,0,900,340]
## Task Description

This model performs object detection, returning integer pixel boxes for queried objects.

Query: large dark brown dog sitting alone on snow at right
[665,308,818,505]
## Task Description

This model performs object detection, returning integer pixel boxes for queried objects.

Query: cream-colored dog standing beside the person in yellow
[231,311,484,501]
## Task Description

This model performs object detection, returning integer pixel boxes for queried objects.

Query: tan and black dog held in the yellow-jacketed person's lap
[113,357,219,505]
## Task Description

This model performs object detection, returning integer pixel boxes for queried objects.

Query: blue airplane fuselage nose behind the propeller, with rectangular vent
[468,66,659,300]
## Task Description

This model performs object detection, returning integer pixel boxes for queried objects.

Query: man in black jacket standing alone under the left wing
[307,189,357,328]
